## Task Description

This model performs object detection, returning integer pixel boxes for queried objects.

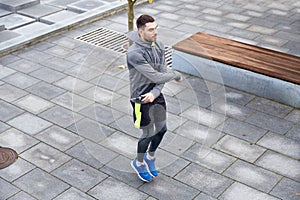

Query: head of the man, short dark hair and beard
[136,15,157,42]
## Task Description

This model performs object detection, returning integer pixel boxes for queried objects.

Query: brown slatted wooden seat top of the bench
[173,33,300,84]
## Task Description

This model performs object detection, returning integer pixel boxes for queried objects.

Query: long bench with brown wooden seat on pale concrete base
[173,32,300,107]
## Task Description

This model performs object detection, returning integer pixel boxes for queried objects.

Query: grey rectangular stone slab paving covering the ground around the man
[0,0,300,200]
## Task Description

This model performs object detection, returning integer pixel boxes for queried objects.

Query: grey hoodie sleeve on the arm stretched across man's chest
[127,52,181,84]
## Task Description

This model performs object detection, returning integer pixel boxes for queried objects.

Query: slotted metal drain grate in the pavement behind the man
[75,27,172,67]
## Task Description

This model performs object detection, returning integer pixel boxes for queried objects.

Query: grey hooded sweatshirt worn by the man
[127,31,181,103]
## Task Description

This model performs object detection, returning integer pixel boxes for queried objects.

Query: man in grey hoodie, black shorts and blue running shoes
[127,15,182,182]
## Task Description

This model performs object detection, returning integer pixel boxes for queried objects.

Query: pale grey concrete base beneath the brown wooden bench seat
[172,50,300,108]
